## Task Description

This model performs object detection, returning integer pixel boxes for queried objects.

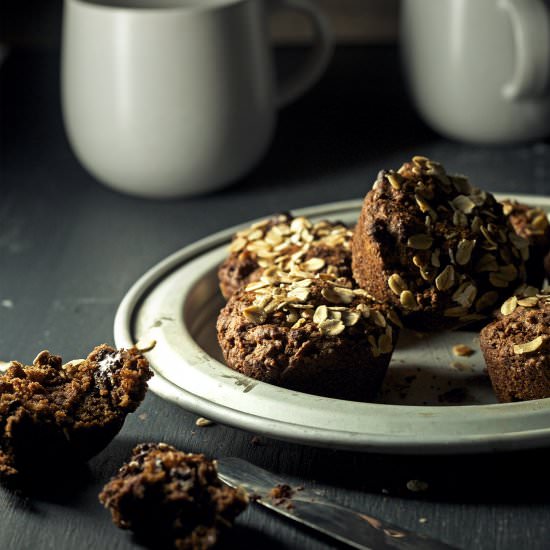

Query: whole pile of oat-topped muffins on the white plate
[217,156,550,401]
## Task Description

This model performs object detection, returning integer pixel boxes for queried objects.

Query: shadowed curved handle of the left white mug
[275,0,334,108]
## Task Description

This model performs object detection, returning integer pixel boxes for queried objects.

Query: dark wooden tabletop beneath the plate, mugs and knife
[0,47,550,550]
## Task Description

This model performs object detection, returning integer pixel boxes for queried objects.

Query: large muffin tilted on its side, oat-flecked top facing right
[352,156,529,331]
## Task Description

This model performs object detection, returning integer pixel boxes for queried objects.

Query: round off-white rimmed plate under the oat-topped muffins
[114,196,550,454]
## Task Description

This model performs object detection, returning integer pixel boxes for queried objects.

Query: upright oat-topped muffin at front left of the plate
[217,268,400,401]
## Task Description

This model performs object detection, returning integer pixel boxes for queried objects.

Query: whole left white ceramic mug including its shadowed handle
[61,0,332,198]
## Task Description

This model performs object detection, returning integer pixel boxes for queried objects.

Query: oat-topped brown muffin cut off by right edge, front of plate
[480,292,550,402]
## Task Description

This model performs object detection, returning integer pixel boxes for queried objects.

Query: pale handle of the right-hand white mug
[498,0,550,101]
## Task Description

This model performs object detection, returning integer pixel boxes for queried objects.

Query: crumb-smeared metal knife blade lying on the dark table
[217,458,460,550]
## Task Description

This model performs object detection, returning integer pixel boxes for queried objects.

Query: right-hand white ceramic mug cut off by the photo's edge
[401,0,550,144]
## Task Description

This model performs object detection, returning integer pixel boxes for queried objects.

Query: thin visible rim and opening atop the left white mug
[65,0,247,13]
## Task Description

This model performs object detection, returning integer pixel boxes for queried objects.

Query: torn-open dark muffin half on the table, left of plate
[0,344,152,482]
